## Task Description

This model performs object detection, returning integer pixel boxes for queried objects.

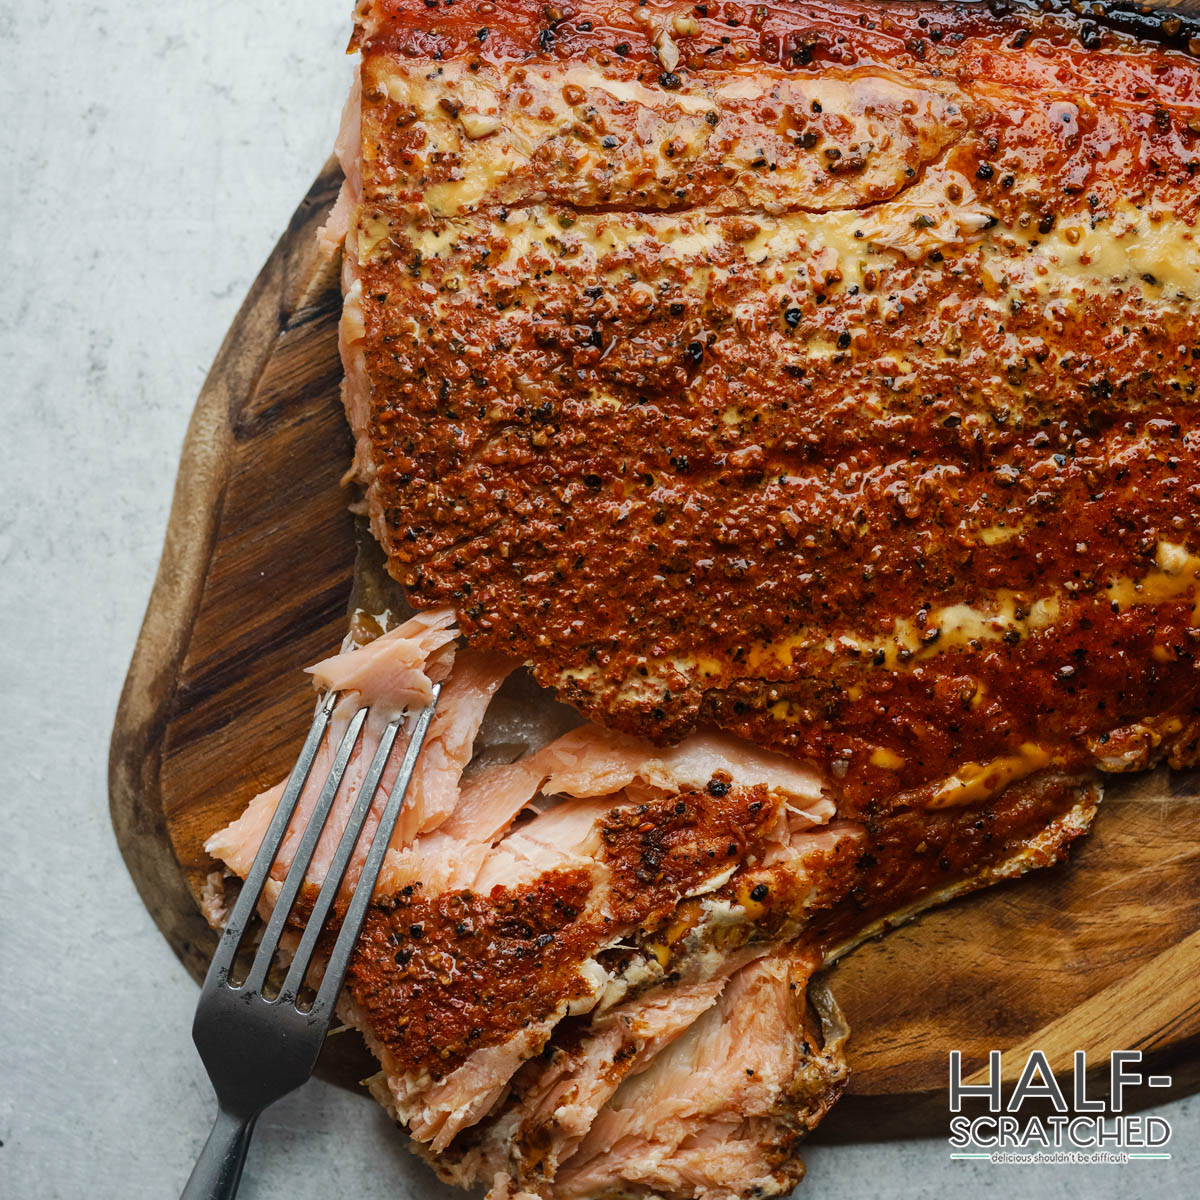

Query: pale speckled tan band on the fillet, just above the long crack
[364,60,967,216]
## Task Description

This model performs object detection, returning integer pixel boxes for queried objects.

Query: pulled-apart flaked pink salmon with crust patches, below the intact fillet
[208,612,1094,1196]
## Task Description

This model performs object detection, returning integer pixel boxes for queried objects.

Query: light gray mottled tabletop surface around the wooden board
[0,0,1200,1200]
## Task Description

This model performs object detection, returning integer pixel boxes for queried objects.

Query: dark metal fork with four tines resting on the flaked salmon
[181,684,442,1200]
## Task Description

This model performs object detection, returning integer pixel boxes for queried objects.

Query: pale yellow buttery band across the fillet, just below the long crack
[358,187,1200,348]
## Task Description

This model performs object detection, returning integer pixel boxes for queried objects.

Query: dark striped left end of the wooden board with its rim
[109,161,354,977]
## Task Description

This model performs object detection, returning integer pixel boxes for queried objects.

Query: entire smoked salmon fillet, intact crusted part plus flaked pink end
[208,0,1200,1200]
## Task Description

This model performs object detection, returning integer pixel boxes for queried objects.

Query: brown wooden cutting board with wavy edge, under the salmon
[109,163,1200,1140]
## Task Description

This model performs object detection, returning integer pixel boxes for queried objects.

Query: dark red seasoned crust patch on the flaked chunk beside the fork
[347,788,778,1079]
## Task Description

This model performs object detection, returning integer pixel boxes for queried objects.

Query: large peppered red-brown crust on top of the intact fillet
[350,4,1200,814]
